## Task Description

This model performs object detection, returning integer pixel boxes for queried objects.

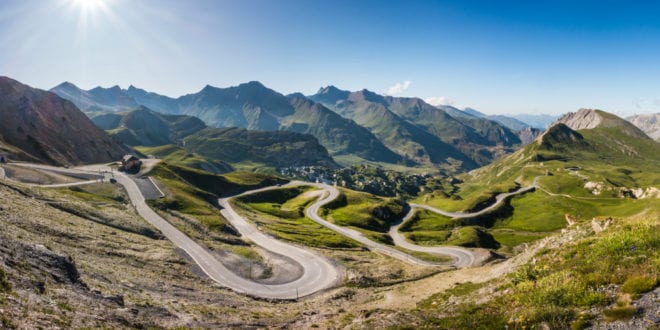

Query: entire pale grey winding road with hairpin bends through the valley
[5,163,540,299]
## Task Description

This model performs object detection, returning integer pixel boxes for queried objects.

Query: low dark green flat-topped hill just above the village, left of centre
[185,127,338,168]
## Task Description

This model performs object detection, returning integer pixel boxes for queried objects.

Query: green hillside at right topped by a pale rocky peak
[407,111,660,253]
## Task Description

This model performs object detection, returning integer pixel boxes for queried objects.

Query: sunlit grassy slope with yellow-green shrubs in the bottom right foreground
[418,209,660,329]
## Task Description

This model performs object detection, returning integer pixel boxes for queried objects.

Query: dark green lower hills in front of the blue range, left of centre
[90,106,337,173]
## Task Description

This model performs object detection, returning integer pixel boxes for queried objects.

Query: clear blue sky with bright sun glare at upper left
[0,0,660,115]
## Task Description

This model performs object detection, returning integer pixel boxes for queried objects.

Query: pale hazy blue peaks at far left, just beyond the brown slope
[50,82,138,112]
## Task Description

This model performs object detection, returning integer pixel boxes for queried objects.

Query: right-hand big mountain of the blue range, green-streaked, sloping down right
[309,86,520,168]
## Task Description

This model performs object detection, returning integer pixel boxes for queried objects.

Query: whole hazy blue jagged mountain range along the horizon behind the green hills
[51,81,534,170]
